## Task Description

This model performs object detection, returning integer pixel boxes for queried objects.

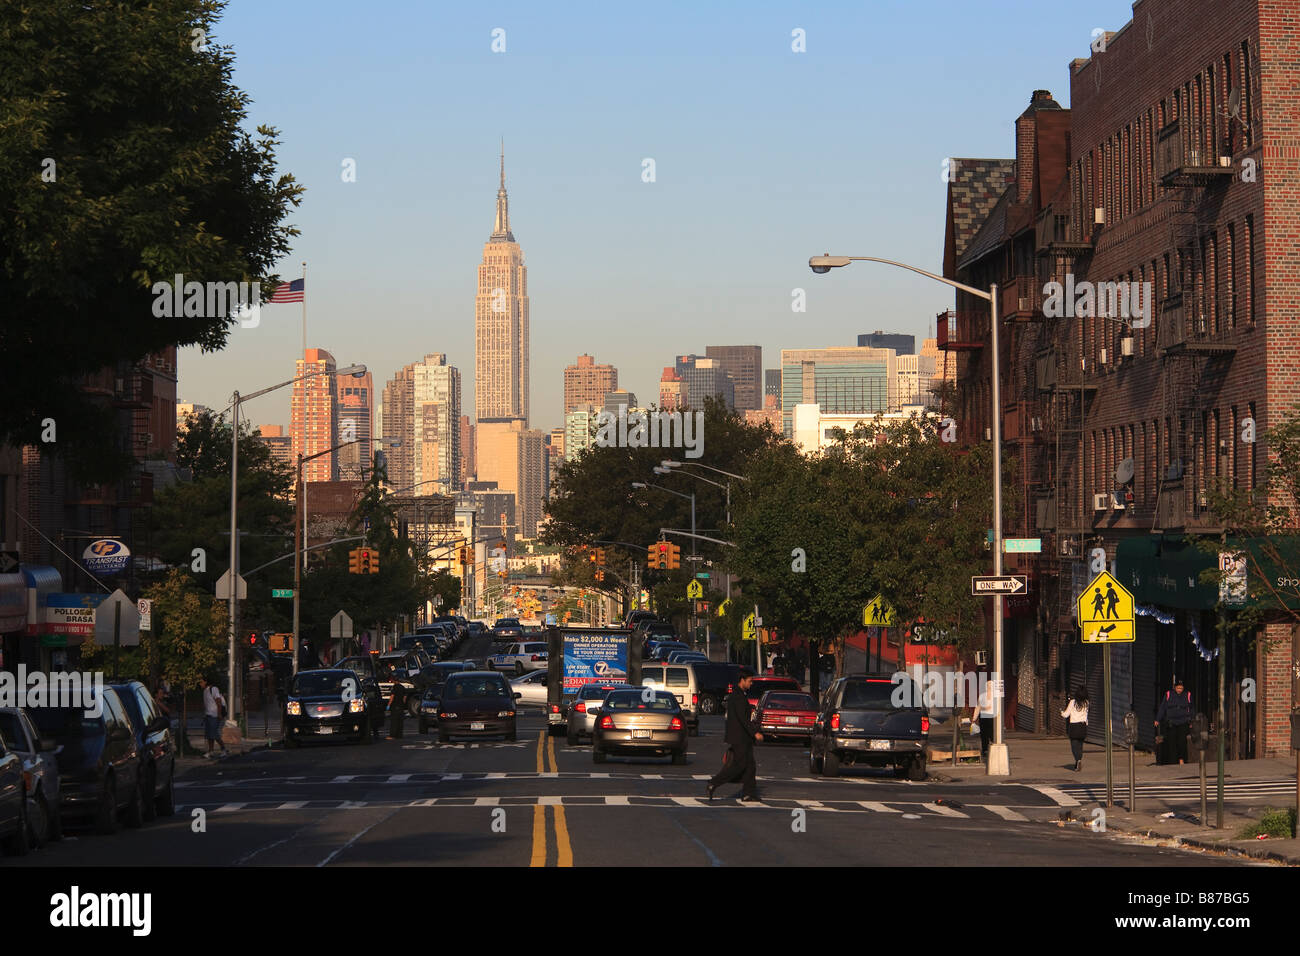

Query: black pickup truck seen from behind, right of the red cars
[811,674,930,780]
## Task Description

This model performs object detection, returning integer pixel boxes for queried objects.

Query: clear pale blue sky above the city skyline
[178,0,1132,429]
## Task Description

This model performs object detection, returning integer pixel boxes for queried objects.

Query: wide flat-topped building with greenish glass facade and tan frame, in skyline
[781,346,898,438]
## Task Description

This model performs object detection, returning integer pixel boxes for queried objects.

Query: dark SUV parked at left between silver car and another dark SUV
[27,687,144,834]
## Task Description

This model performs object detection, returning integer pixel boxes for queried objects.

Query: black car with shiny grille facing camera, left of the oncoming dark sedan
[283,667,384,749]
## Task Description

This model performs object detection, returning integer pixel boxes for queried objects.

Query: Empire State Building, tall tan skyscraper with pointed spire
[475,150,528,428]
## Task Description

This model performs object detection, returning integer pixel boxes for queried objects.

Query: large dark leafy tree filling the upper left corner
[0,0,302,479]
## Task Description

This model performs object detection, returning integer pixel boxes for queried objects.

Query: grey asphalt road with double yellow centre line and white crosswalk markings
[3,639,1258,866]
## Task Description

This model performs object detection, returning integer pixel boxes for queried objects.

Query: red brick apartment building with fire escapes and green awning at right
[937,0,1300,757]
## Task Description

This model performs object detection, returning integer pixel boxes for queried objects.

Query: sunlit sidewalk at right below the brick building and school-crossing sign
[928,724,1300,865]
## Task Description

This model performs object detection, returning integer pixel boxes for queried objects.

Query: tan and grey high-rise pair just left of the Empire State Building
[384,352,462,494]
